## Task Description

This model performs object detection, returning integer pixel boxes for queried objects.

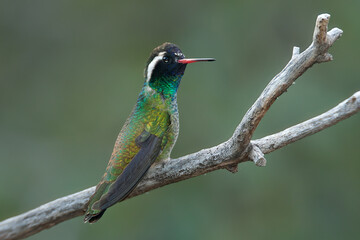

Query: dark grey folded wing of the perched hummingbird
[93,131,162,210]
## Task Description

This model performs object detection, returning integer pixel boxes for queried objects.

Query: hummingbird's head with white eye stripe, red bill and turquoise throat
[145,42,215,97]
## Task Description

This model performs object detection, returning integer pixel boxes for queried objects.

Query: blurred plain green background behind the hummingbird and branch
[0,0,360,240]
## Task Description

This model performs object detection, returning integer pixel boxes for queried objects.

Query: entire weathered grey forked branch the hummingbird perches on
[0,14,360,239]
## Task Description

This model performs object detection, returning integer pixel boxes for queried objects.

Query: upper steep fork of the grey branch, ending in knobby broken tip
[230,14,342,154]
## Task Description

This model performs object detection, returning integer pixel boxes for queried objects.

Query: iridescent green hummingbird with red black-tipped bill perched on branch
[84,42,215,223]
